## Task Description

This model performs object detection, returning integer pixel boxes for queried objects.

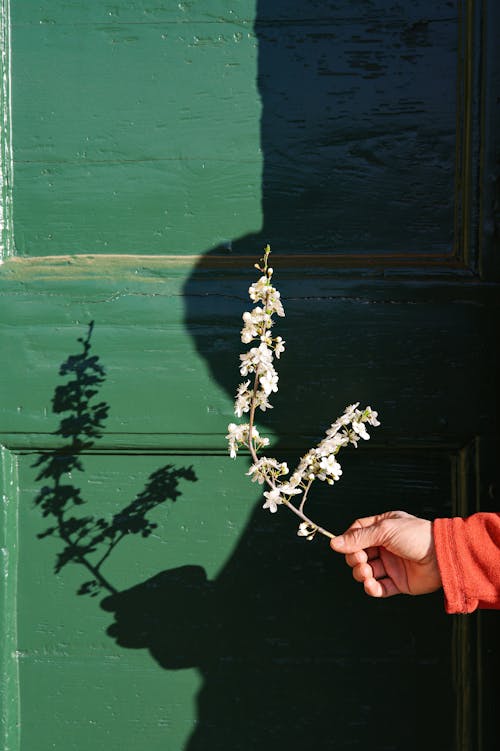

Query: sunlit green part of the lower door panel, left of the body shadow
[14,454,256,749]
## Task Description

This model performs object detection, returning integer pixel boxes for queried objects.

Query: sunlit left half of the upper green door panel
[12,2,262,257]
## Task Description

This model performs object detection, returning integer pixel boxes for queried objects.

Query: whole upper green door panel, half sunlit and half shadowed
[12,0,463,256]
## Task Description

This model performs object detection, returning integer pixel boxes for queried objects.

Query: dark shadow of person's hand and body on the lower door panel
[101,488,447,751]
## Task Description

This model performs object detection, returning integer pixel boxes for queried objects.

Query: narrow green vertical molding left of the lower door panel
[0,446,20,751]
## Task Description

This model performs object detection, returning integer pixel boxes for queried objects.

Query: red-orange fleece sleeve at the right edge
[433,512,500,613]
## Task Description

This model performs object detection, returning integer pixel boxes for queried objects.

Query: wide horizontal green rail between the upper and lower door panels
[0,262,499,448]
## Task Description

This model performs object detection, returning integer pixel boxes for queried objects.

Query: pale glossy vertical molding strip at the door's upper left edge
[0,0,14,263]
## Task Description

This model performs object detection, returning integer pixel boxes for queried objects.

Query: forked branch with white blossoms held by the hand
[226,250,380,540]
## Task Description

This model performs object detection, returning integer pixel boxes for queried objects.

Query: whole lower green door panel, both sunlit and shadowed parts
[0,451,460,750]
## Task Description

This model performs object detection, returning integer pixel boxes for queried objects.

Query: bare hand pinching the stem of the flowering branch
[330,511,441,597]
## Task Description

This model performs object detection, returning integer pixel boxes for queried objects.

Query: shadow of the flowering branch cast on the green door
[33,321,197,596]
